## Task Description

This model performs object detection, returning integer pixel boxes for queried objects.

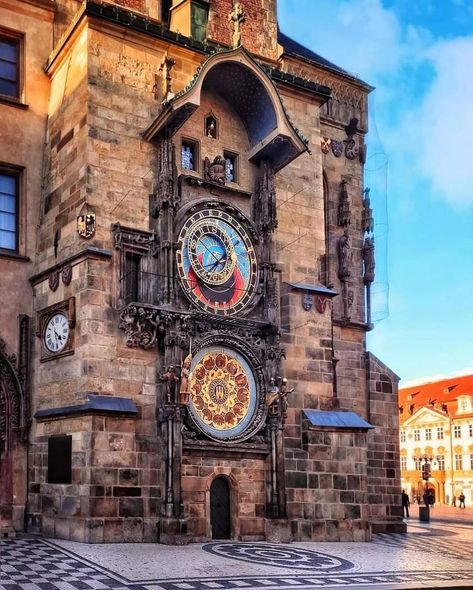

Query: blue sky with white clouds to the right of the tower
[278,0,473,386]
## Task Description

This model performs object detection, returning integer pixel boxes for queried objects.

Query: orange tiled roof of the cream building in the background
[399,375,473,418]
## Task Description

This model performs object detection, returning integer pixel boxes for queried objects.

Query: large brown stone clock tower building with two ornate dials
[0,0,403,543]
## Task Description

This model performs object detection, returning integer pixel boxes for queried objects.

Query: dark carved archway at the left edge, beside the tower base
[0,340,27,534]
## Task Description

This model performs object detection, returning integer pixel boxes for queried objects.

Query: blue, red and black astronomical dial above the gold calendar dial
[177,209,257,315]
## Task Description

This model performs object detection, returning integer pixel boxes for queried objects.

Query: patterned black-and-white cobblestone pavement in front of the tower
[0,522,473,590]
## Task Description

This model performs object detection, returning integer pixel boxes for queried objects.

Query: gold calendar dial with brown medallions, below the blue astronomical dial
[189,347,257,441]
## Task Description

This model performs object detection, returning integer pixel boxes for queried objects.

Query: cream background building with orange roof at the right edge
[399,375,473,505]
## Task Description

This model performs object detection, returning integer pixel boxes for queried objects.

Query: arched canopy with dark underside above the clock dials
[144,47,326,172]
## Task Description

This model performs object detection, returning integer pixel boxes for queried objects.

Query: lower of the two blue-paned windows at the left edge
[0,168,20,252]
